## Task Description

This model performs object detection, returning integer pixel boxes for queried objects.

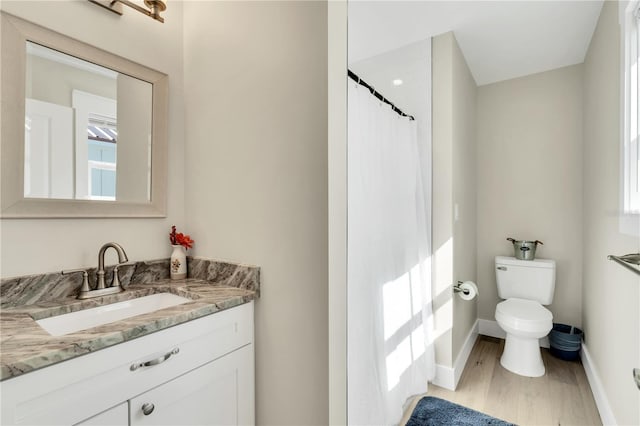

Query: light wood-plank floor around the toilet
[400,336,602,426]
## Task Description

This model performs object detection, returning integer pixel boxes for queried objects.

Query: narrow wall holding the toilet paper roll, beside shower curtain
[432,32,476,367]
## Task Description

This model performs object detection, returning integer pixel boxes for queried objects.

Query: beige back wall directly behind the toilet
[477,65,583,326]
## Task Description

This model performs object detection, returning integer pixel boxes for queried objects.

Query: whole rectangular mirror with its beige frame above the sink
[0,13,168,218]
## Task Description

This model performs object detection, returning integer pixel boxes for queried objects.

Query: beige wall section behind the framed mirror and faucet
[0,0,185,277]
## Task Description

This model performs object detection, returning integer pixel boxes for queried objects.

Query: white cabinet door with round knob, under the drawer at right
[129,345,255,425]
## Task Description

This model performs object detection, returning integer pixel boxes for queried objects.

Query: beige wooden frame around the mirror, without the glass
[0,12,169,218]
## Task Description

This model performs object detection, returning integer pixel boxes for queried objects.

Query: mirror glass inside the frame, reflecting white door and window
[24,42,152,203]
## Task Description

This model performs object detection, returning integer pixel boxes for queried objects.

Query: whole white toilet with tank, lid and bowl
[495,256,556,377]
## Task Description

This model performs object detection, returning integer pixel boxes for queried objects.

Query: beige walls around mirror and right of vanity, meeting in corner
[5,1,329,425]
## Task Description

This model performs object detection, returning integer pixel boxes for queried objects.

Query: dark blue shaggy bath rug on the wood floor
[407,396,515,426]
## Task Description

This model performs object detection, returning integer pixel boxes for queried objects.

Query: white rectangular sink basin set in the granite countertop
[36,293,191,336]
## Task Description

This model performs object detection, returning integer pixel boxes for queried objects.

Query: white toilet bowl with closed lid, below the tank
[496,298,553,377]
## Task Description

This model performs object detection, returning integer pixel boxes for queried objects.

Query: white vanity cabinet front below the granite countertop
[0,302,255,426]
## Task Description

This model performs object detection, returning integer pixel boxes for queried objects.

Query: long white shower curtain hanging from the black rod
[347,79,435,425]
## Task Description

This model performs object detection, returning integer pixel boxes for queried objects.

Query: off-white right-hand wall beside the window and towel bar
[582,2,640,425]
